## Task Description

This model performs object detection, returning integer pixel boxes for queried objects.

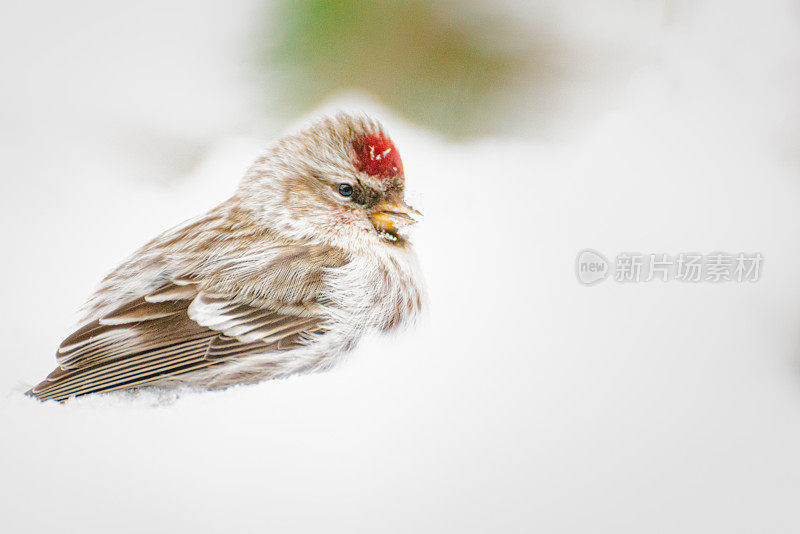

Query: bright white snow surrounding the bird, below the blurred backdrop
[0,3,800,533]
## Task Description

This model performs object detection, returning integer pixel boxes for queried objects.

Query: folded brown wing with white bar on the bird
[28,280,321,401]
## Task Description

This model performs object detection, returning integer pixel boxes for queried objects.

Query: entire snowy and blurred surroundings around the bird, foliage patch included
[0,0,800,534]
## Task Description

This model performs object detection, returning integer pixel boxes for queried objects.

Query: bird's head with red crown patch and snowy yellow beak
[237,113,420,248]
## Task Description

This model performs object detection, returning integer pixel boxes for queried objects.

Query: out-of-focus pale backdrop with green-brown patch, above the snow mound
[0,0,676,180]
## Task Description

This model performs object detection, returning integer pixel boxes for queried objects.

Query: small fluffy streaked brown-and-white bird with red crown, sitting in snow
[28,113,423,401]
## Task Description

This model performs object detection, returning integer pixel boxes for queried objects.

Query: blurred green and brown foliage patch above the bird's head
[261,0,536,137]
